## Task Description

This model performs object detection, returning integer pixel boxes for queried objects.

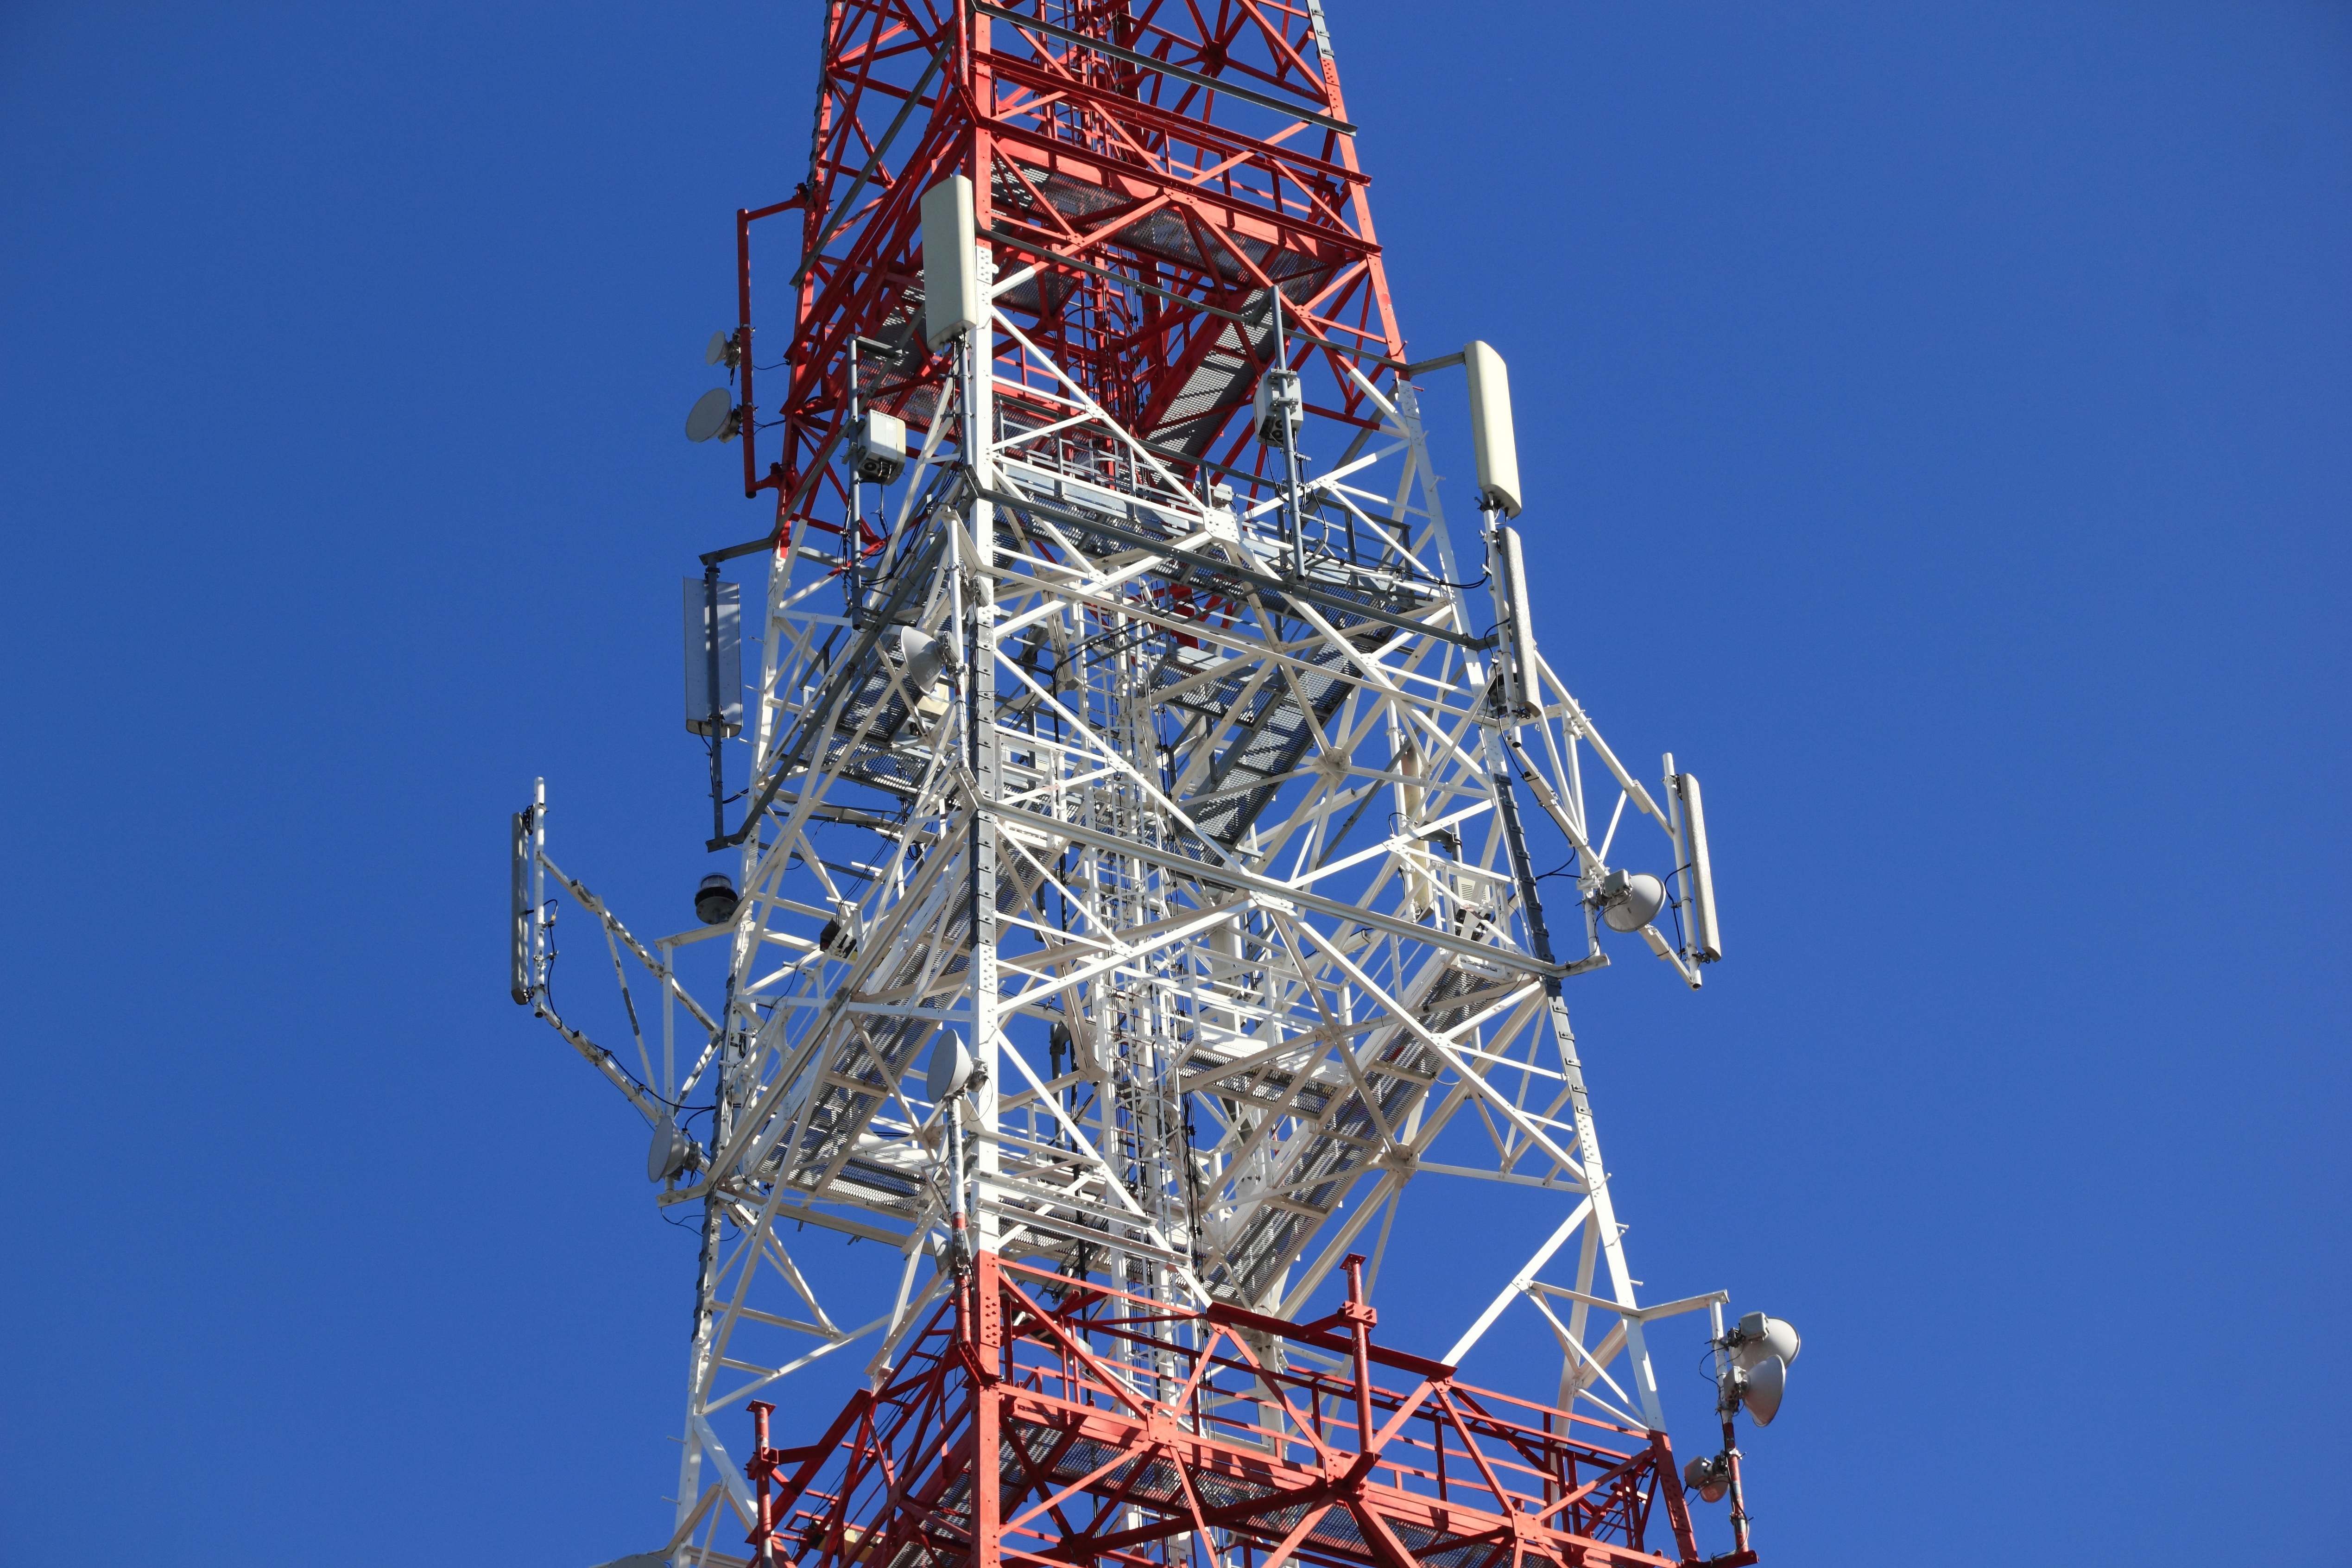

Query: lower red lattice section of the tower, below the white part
[746,1253,1698,1568]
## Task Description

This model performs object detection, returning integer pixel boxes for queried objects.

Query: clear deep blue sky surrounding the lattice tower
[0,0,2352,1568]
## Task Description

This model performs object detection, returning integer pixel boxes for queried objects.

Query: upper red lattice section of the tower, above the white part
[739,0,1404,531]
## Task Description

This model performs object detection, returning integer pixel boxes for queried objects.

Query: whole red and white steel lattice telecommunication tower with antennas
[510,0,1797,1568]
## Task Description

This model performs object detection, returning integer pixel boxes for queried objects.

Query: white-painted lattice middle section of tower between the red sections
[529,282,1712,1554]
